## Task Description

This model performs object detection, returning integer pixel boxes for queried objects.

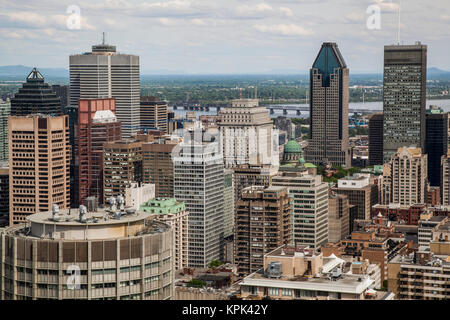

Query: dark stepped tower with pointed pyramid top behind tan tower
[11,68,63,116]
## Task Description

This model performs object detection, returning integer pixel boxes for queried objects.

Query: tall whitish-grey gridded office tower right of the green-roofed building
[173,137,224,268]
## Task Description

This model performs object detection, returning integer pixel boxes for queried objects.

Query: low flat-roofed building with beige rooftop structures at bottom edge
[240,247,394,300]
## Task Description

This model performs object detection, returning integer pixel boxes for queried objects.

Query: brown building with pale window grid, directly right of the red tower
[103,140,142,203]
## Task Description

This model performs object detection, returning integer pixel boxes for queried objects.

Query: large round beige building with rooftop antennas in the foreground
[0,203,174,300]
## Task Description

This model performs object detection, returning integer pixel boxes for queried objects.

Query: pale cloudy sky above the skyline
[0,0,450,74]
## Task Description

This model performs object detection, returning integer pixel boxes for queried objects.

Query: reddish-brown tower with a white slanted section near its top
[75,98,121,207]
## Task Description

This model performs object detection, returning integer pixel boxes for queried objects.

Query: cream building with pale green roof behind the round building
[140,198,189,270]
